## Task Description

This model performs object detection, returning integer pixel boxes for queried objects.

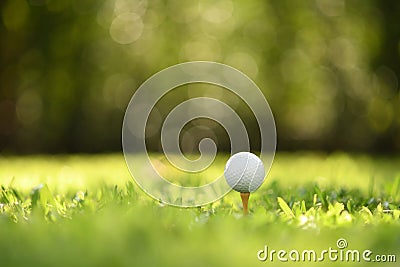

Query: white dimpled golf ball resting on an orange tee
[224,152,265,193]
